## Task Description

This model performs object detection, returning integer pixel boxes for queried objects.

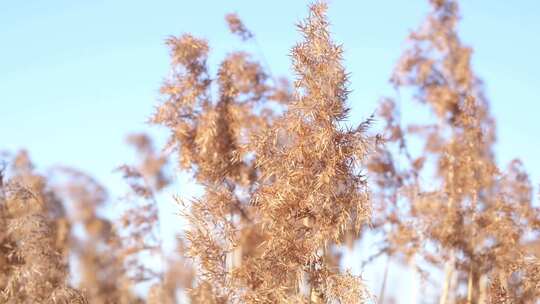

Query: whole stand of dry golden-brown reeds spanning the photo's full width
[0,0,540,304]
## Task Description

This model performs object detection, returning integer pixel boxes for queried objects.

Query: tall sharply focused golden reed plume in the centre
[249,3,370,303]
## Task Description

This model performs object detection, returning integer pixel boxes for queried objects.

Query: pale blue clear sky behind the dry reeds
[0,0,540,302]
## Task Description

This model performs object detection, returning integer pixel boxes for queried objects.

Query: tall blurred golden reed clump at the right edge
[370,0,540,303]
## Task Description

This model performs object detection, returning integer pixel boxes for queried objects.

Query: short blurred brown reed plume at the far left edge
[0,151,87,303]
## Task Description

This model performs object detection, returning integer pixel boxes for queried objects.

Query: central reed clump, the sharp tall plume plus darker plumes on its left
[154,4,369,303]
